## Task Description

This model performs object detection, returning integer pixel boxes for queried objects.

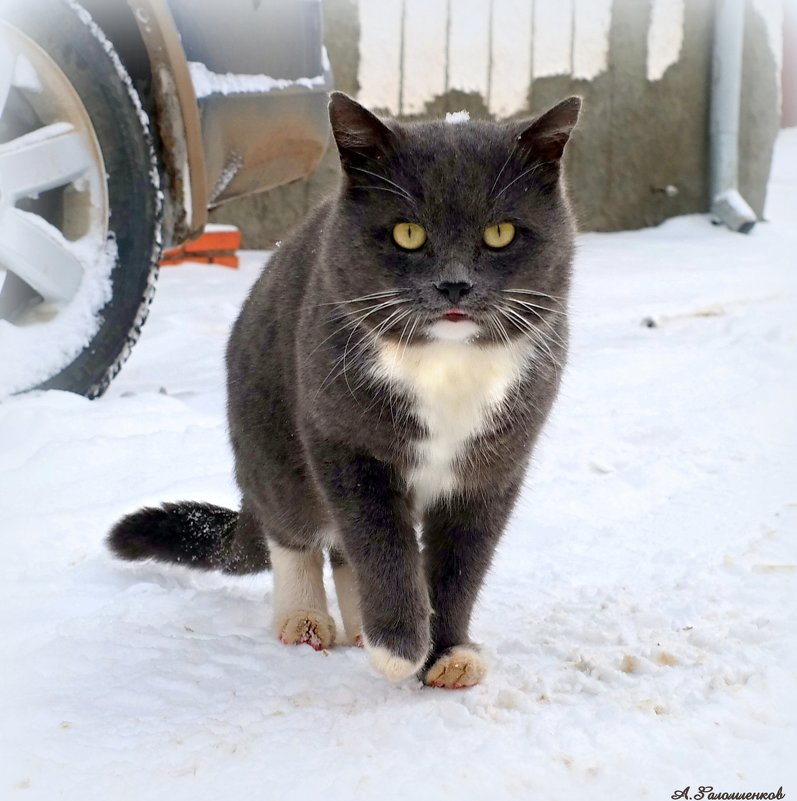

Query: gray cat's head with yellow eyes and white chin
[323,92,581,342]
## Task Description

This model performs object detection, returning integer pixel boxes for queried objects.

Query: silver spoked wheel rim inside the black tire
[0,22,108,314]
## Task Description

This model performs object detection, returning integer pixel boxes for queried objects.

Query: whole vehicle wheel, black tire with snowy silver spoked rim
[0,0,162,397]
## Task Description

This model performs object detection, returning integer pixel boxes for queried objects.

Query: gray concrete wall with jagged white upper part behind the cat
[212,0,783,247]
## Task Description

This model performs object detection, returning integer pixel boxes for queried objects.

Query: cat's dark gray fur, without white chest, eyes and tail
[107,93,580,680]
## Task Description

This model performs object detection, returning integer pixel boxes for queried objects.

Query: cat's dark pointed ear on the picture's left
[329,92,396,168]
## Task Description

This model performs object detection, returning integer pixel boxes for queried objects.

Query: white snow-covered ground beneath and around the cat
[0,130,797,801]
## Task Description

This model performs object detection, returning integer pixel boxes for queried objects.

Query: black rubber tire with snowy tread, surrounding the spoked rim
[0,0,162,398]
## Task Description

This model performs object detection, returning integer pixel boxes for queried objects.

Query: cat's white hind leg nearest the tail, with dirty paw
[269,539,335,651]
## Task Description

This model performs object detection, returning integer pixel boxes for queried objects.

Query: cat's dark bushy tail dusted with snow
[108,501,271,574]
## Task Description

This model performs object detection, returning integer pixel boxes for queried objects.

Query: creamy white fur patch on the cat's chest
[375,340,531,508]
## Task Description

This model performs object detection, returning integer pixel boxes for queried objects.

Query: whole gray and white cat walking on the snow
[109,93,581,687]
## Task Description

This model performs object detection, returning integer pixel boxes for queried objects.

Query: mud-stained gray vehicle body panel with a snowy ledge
[169,0,332,206]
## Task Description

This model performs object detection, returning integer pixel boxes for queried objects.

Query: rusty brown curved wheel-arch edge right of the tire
[127,0,208,244]
